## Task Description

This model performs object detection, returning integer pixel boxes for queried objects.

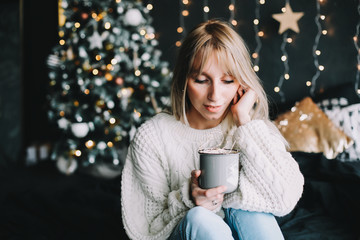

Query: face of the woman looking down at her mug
[186,55,240,129]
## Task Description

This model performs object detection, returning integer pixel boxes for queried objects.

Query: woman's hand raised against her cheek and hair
[231,86,257,126]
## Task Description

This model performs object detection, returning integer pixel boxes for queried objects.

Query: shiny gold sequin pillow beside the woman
[274,97,353,159]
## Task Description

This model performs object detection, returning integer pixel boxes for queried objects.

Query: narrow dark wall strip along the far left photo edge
[0,0,23,167]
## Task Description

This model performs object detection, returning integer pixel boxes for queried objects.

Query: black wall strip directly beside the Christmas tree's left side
[23,0,58,146]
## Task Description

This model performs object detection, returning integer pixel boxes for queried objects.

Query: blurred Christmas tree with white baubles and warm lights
[47,0,171,176]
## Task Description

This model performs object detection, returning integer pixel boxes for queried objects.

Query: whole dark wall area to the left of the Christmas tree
[0,0,58,167]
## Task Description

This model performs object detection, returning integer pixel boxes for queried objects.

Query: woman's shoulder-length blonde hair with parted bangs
[171,20,269,123]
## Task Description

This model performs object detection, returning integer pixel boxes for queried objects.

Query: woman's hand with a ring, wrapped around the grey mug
[190,170,226,211]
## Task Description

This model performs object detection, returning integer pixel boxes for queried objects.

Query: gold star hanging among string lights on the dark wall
[272,3,304,34]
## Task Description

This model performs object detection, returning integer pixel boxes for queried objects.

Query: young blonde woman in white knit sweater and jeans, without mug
[121,20,304,240]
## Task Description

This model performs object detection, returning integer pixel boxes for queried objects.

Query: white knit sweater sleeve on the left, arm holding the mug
[121,118,193,239]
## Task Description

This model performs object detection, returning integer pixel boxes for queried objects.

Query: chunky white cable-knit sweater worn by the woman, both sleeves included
[121,113,304,240]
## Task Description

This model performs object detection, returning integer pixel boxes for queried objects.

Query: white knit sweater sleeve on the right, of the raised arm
[223,120,304,216]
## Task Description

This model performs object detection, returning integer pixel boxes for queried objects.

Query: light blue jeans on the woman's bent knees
[168,207,284,240]
